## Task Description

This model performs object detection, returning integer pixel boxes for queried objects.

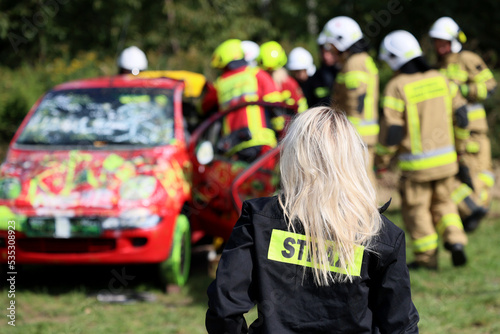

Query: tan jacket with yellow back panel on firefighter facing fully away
[375,70,460,182]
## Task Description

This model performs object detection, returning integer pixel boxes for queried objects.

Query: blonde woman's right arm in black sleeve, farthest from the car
[370,217,419,334]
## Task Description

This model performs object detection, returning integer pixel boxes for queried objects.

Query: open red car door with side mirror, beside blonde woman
[188,102,296,240]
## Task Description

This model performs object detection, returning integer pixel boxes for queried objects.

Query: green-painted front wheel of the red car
[160,214,191,286]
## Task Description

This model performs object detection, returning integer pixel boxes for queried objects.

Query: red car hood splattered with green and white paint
[0,146,190,216]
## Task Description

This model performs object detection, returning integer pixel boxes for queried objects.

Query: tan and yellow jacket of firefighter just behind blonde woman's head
[333,52,379,145]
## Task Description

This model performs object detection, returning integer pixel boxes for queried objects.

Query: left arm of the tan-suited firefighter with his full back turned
[375,85,405,172]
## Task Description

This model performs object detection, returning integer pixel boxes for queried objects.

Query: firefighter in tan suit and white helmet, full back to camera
[376,30,467,269]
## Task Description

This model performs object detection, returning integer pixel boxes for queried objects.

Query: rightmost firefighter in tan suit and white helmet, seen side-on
[429,17,496,231]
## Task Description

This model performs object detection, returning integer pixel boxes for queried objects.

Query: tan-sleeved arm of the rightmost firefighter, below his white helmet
[460,53,497,102]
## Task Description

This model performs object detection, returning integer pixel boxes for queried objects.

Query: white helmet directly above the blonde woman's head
[318,16,363,52]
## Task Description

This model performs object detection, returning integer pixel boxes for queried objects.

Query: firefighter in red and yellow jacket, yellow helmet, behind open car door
[202,39,281,162]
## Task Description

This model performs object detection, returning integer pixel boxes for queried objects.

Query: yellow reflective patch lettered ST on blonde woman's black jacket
[267,230,364,276]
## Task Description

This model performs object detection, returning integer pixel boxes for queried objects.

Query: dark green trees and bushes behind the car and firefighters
[0,0,500,153]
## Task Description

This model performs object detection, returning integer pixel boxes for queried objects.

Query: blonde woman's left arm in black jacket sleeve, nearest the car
[205,203,256,334]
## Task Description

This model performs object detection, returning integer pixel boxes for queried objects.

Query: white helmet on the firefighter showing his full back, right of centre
[379,30,422,71]
